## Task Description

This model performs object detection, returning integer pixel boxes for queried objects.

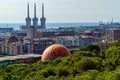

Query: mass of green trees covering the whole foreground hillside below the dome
[0,40,120,80]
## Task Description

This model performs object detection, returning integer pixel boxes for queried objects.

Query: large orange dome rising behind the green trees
[41,44,71,61]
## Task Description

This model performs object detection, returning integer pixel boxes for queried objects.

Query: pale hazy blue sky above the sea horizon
[0,0,120,23]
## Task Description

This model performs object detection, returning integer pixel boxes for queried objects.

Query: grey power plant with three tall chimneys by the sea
[20,3,46,30]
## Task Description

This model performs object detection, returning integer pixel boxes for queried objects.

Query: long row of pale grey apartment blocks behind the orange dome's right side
[55,36,101,48]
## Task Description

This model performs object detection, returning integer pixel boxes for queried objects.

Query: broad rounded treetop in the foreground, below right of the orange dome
[74,57,102,73]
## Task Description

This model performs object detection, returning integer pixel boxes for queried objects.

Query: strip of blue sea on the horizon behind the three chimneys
[0,22,99,30]
